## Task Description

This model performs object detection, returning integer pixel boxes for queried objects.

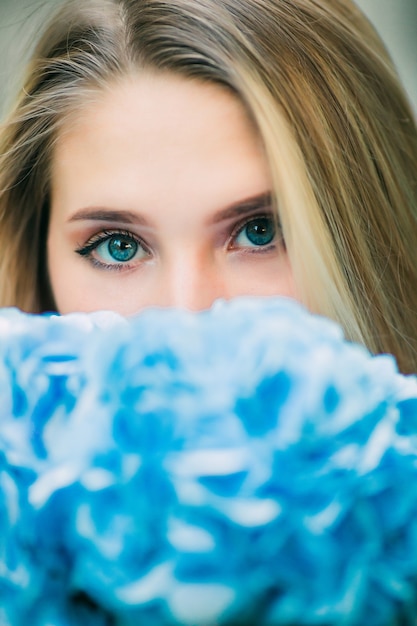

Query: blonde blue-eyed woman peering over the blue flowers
[0,0,417,372]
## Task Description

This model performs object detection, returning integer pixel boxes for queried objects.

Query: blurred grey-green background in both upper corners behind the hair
[0,0,417,119]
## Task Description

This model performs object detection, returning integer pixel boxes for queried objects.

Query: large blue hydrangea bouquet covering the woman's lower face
[0,298,417,626]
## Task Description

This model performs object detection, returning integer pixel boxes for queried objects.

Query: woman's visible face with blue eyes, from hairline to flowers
[48,74,296,315]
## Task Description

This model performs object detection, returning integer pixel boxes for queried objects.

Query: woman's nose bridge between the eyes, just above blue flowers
[164,248,227,311]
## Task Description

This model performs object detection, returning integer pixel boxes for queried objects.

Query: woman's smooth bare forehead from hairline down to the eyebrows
[52,74,266,214]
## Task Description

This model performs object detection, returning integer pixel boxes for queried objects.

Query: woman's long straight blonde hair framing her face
[0,0,417,371]
